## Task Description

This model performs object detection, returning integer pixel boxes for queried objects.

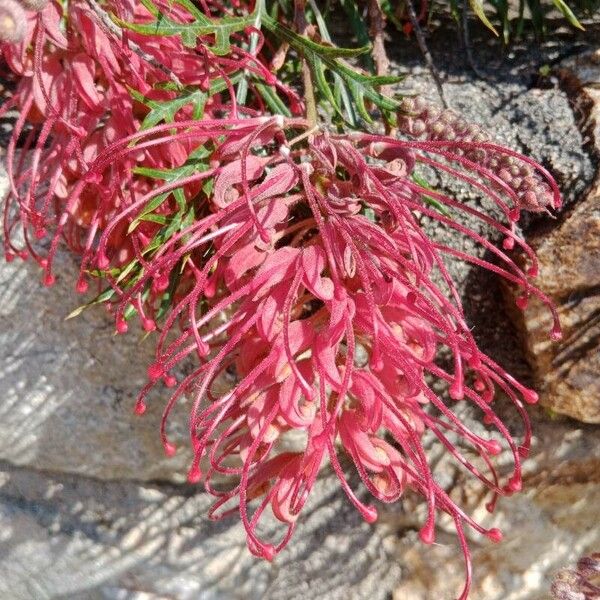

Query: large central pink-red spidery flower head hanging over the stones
[65,118,559,598]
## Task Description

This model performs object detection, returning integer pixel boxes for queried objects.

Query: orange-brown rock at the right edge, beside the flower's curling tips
[506,51,600,423]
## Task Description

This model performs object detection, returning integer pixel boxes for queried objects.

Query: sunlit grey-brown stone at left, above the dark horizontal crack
[0,171,193,481]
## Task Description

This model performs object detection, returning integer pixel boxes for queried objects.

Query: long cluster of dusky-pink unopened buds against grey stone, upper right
[398,97,553,212]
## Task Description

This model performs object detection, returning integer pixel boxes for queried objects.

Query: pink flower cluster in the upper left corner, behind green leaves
[0,0,302,292]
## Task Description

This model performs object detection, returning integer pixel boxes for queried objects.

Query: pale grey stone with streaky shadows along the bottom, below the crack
[0,462,399,600]
